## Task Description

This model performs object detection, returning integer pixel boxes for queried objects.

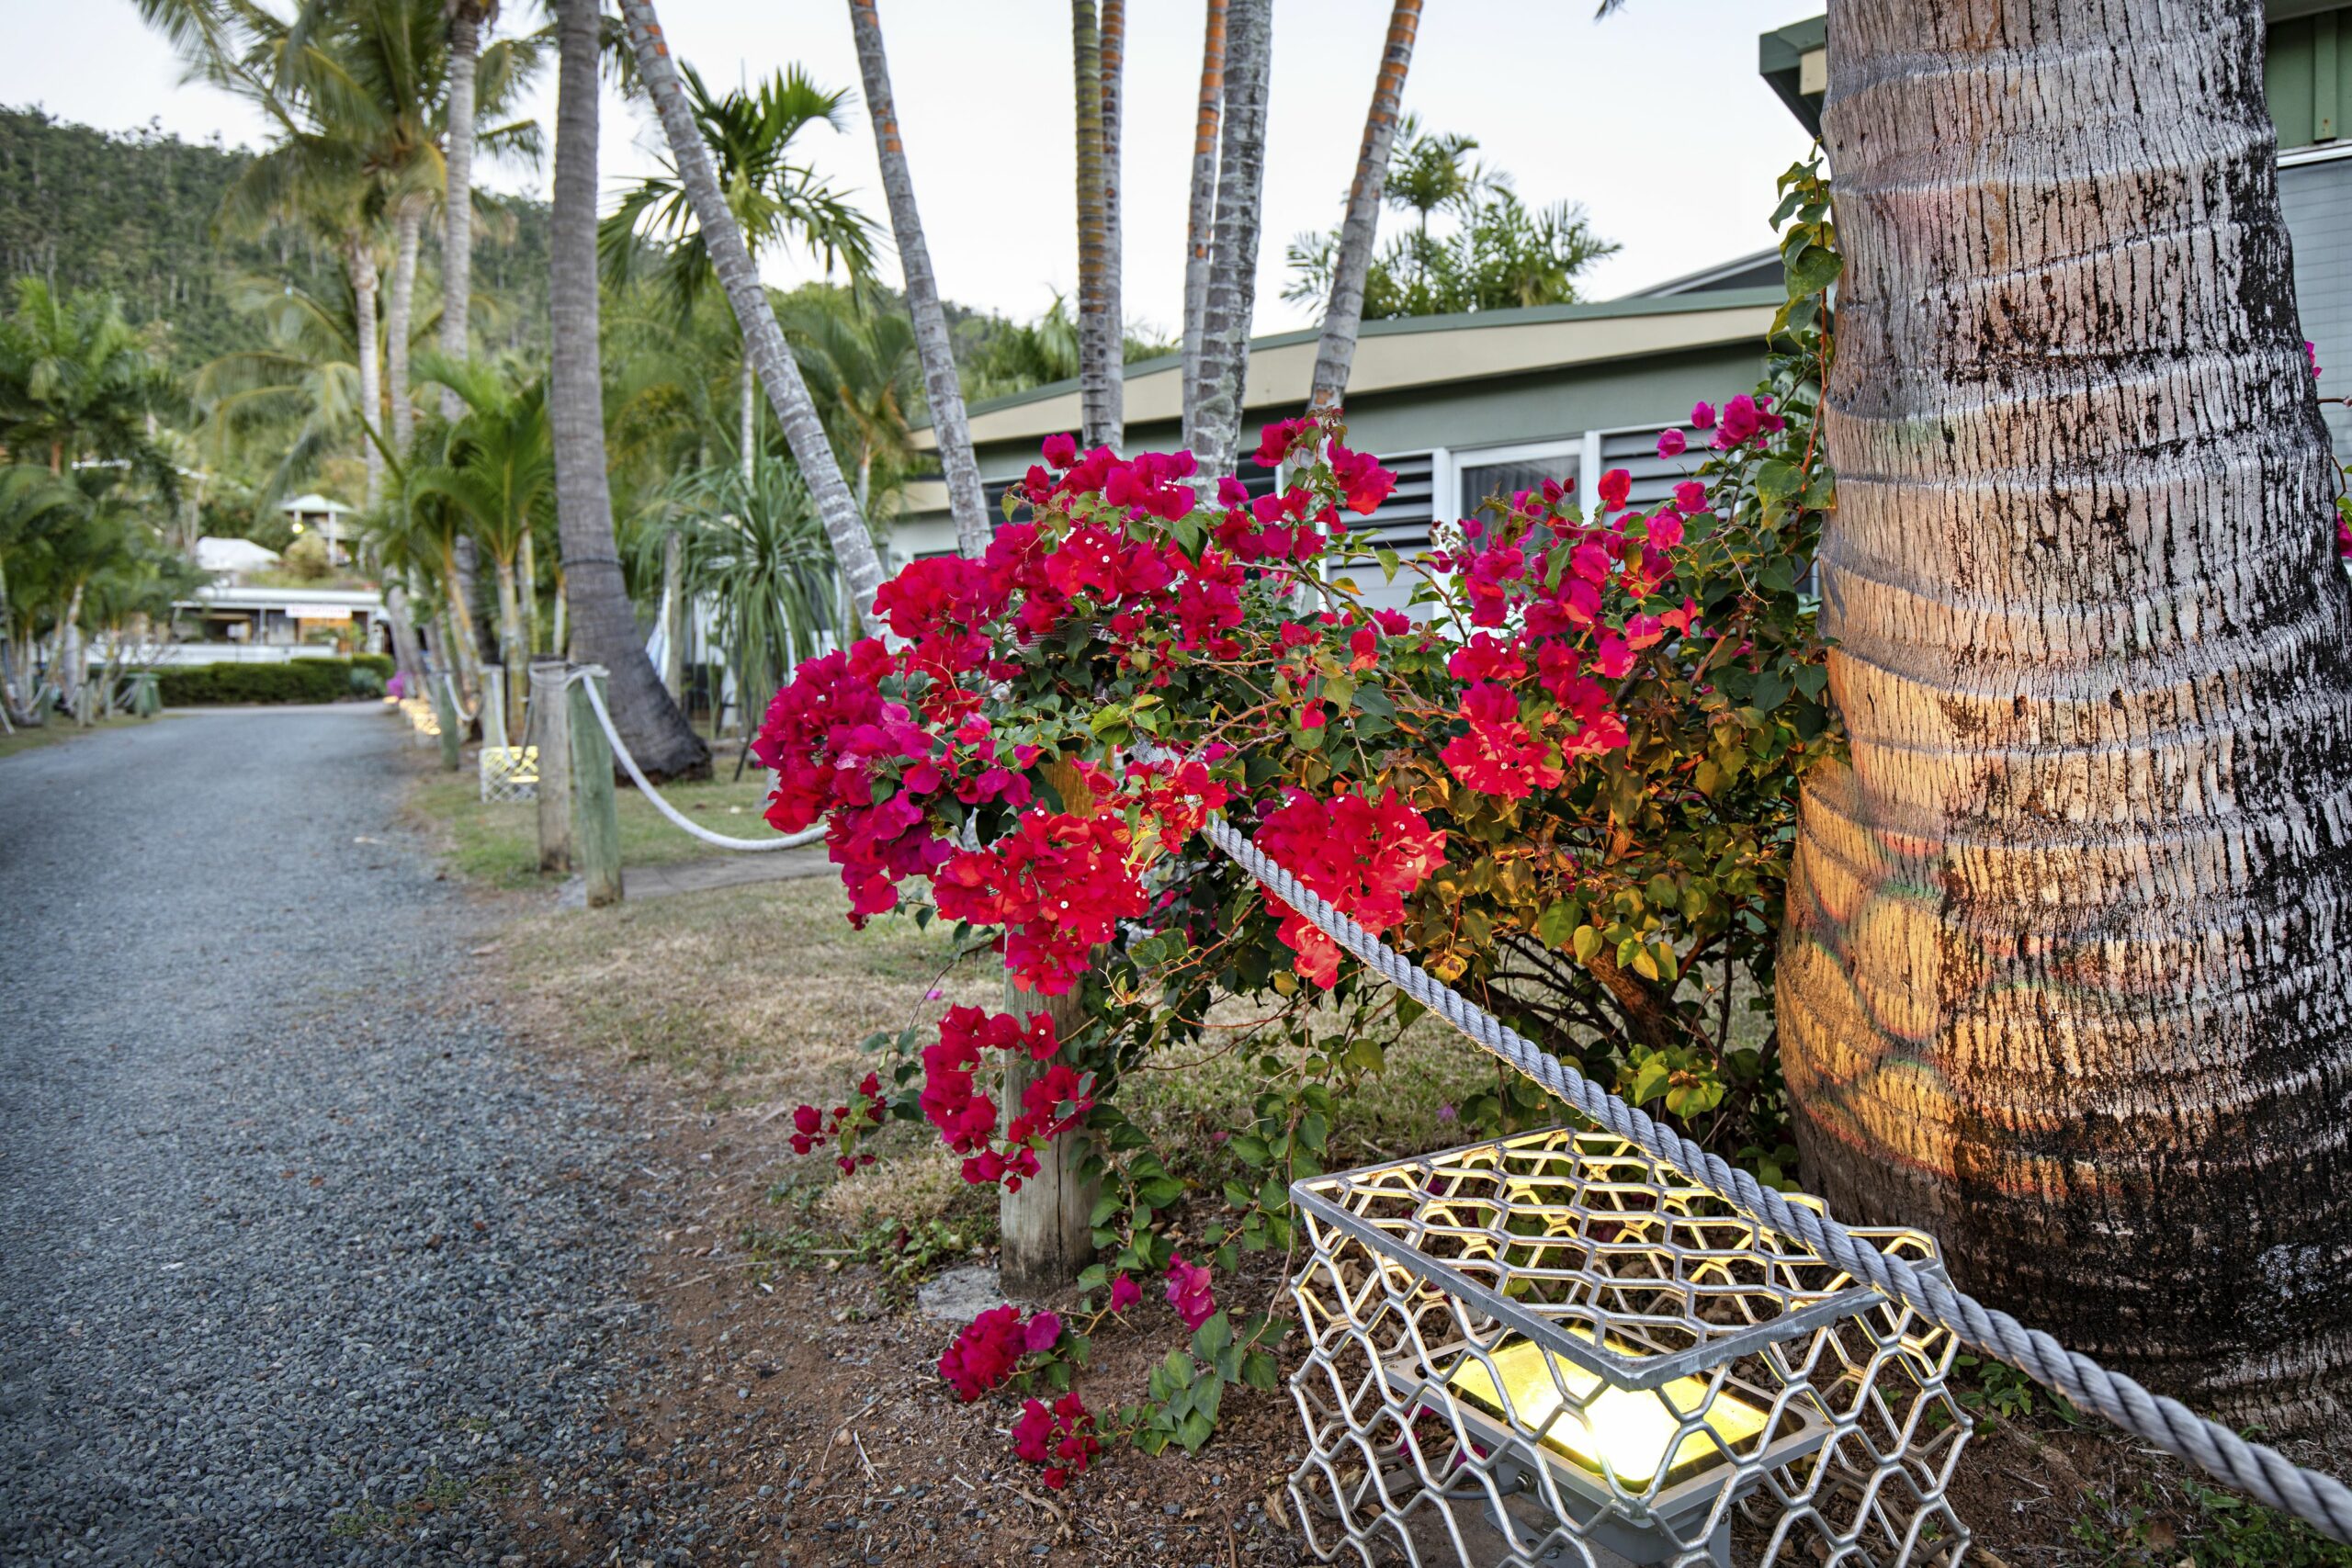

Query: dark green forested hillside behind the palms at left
[0,108,548,371]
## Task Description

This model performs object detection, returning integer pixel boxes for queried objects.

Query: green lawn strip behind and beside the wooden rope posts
[409,750,790,888]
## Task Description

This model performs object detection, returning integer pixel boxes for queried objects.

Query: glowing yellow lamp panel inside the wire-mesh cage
[1446,1328,1767,1485]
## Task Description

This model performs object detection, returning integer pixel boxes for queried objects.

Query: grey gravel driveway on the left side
[0,707,635,1563]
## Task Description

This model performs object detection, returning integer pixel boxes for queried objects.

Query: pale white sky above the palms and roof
[0,0,1820,333]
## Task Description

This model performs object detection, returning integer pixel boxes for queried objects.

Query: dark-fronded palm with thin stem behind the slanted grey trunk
[597,66,873,484]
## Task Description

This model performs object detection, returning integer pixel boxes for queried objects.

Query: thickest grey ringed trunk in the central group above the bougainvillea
[1193,0,1275,475]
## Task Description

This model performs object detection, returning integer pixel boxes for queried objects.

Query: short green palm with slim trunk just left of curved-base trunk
[407,353,555,740]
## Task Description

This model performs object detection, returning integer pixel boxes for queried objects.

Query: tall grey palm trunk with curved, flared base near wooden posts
[548,0,710,778]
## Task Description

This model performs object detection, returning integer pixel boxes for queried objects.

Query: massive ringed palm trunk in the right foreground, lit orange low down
[1781,0,2352,1432]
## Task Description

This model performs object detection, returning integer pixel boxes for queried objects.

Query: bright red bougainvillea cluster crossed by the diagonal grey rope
[1251,787,1446,989]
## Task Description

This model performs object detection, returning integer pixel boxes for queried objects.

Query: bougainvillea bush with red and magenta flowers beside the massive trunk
[755,172,1837,1485]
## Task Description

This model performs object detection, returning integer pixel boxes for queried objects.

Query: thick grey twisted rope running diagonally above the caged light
[1204,816,2352,1544]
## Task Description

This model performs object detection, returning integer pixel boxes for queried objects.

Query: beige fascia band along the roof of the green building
[915,289,1785,449]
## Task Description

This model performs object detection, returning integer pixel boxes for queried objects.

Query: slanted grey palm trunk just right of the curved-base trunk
[621,0,882,635]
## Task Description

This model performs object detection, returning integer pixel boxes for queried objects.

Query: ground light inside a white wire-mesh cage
[1289,1128,1971,1568]
